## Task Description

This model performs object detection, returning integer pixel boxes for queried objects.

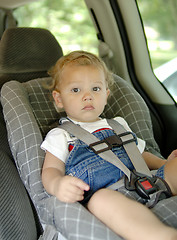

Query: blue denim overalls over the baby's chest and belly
[65,129,134,195]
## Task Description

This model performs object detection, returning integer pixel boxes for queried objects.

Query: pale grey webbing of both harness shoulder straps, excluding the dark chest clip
[60,119,152,181]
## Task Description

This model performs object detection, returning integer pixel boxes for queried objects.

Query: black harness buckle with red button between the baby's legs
[125,170,159,200]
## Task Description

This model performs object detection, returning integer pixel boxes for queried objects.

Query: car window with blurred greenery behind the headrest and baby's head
[14,0,98,54]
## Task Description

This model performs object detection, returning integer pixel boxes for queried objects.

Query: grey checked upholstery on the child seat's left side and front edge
[1,79,120,240]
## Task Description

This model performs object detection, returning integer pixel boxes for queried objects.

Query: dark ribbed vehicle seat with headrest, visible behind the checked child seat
[0,28,63,240]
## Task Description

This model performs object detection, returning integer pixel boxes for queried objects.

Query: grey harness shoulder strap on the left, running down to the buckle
[60,121,131,181]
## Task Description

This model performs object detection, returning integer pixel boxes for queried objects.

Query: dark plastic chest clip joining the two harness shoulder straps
[89,132,136,154]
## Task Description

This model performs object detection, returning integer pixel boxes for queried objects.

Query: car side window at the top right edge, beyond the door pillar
[137,0,177,101]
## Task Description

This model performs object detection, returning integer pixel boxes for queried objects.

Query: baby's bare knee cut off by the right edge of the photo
[164,157,177,195]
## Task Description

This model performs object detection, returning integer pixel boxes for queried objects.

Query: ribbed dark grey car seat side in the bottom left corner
[0,151,37,240]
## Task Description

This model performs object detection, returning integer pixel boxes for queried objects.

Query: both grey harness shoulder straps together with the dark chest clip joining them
[60,119,152,181]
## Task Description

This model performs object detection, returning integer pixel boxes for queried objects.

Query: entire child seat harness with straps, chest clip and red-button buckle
[59,119,171,208]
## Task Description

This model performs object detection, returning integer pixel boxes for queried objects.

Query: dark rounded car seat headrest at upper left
[0,28,63,86]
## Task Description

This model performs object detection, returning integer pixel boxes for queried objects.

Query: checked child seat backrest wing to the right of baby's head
[102,75,161,156]
